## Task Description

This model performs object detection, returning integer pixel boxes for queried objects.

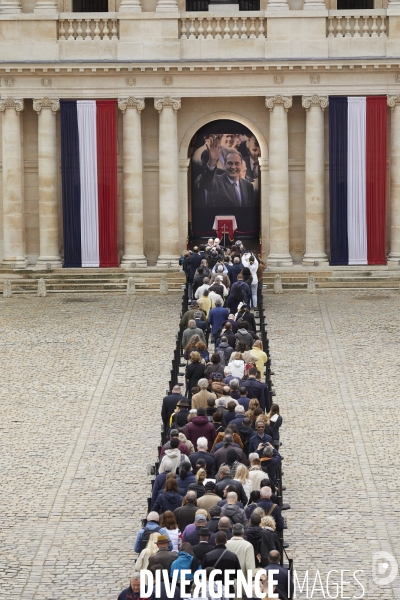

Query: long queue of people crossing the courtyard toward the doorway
[119,239,292,600]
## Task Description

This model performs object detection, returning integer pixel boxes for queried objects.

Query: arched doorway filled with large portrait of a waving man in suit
[188,119,261,251]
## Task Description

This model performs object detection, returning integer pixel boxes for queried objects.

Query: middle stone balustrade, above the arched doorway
[180,14,266,40]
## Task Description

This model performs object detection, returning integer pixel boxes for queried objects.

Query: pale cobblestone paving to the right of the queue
[266,290,400,600]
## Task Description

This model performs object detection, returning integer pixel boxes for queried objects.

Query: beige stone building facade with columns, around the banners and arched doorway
[0,0,400,268]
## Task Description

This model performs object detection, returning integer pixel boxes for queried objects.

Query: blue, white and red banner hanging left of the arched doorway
[60,100,118,267]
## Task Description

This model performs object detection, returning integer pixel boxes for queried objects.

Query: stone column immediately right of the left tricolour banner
[118,97,147,268]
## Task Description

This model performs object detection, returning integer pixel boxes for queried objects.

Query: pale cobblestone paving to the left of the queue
[0,294,180,600]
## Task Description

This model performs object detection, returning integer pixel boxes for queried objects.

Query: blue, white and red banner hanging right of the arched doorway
[329,96,387,265]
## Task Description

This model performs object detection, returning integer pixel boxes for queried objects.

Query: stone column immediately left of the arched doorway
[154,97,184,267]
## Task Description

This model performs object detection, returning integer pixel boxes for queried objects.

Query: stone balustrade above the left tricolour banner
[58,13,119,41]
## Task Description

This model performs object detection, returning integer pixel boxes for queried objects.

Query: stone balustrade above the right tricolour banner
[327,10,388,38]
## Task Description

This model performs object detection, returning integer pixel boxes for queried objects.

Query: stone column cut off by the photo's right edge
[388,94,400,266]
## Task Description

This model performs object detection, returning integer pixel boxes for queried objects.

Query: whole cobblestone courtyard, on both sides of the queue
[0,290,400,600]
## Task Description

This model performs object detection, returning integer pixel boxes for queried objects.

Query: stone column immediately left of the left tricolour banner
[33,98,62,269]
